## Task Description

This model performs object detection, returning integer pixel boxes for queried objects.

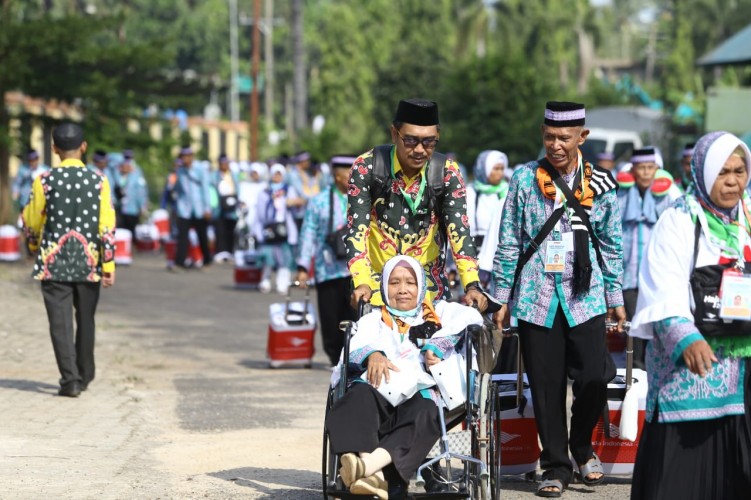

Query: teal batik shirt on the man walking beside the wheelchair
[493,161,623,328]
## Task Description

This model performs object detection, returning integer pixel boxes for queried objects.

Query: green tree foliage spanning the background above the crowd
[0,0,751,221]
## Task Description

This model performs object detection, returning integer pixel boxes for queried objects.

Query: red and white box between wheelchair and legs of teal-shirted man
[492,373,540,475]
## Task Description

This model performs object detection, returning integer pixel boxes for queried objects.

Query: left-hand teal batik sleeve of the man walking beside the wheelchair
[493,168,527,304]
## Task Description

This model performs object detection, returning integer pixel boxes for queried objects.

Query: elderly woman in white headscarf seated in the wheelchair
[326,256,483,498]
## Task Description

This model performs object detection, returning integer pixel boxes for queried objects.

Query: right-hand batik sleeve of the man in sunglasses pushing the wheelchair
[443,160,480,286]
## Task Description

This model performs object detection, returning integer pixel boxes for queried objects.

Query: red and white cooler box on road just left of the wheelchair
[266,287,316,368]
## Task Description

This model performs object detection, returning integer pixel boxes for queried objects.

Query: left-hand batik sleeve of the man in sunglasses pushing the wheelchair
[346,151,373,288]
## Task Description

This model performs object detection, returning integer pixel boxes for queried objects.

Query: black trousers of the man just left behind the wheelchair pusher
[316,277,357,366]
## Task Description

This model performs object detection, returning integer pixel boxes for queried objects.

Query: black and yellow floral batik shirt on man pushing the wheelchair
[347,146,479,305]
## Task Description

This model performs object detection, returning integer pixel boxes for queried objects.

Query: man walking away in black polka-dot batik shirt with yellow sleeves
[22,123,115,397]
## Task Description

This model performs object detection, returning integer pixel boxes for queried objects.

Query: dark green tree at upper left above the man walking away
[0,5,170,221]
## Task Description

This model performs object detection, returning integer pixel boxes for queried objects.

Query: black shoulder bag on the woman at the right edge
[689,222,751,337]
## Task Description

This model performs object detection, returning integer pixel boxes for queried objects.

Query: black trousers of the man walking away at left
[42,281,101,385]
